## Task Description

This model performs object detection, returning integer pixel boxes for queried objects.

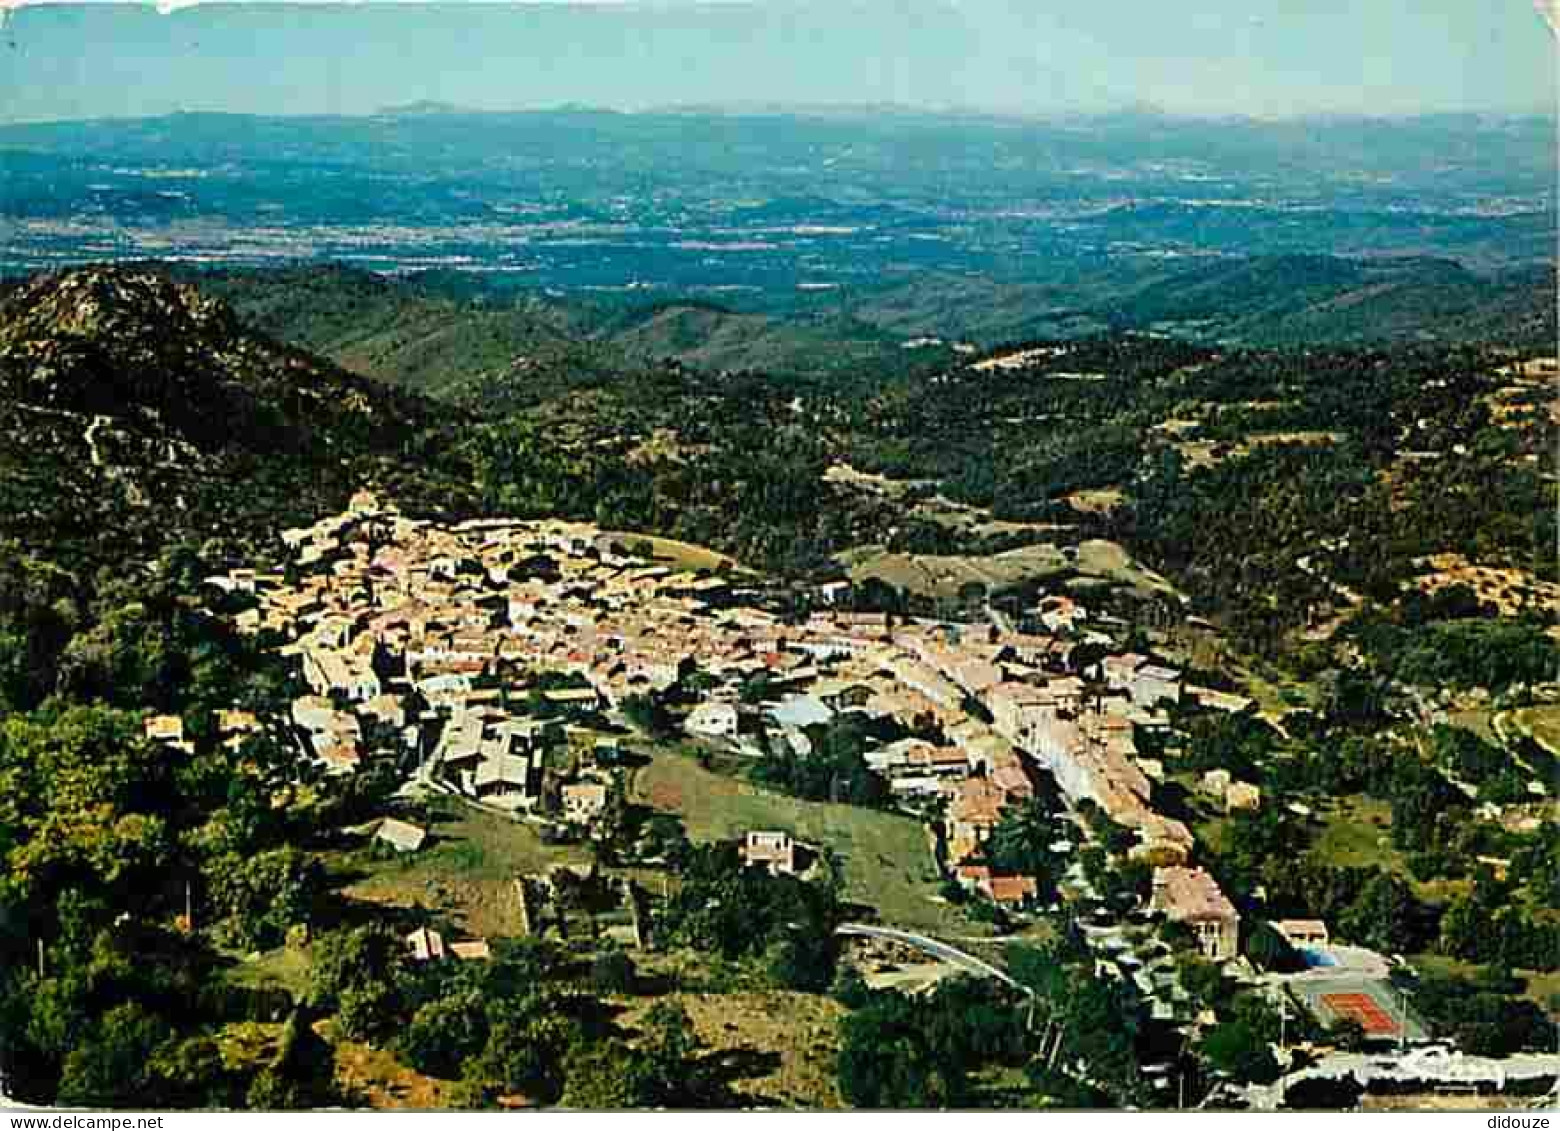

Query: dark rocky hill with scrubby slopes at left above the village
[0,267,467,563]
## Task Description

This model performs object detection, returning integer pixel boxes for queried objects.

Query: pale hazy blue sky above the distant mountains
[0,0,1555,120]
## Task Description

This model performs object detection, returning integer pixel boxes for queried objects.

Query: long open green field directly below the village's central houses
[630,752,973,934]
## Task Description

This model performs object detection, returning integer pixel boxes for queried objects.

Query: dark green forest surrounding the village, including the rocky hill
[0,262,1560,1108]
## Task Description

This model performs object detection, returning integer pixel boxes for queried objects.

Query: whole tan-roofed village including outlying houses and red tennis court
[155,491,1560,1103]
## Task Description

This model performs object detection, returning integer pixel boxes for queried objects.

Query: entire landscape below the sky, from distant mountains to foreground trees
[0,92,1560,1104]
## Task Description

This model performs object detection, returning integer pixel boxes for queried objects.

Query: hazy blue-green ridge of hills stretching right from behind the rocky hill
[187,256,1555,399]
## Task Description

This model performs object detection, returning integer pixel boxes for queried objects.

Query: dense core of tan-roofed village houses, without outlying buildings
[198,493,1260,961]
